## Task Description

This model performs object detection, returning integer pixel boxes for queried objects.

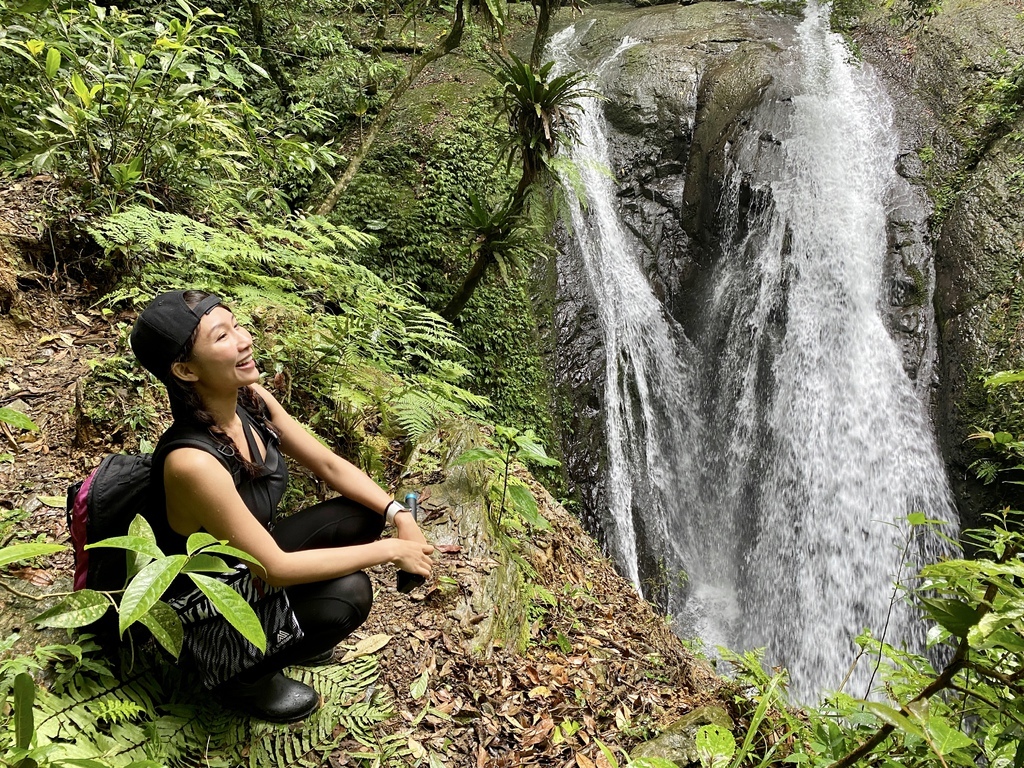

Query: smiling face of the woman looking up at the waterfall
[172,306,259,390]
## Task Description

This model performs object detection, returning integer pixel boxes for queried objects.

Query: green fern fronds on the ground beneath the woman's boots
[7,656,394,768]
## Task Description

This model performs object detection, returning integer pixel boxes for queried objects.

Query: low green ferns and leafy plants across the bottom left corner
[0,626,387,768]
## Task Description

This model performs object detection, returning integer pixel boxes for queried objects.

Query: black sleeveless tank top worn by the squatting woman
[150,404,288,555]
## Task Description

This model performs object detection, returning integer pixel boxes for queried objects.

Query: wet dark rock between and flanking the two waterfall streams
[553,2,954,529]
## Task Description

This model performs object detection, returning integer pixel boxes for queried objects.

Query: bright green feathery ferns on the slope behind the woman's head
[83,207,489,470]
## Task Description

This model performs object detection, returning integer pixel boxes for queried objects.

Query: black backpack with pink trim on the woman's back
[67,429,238,592]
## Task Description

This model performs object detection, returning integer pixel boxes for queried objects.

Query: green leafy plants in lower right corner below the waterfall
[701,512,1024,768]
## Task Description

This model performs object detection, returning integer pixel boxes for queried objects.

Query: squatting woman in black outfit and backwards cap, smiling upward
[131,291,433,722]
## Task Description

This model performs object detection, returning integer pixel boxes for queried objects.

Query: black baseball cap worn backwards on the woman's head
[130,291,223,383]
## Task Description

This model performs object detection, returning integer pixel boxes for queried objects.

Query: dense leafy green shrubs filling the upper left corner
[0,1,337,211]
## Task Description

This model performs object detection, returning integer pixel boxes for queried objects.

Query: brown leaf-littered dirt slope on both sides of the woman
[0,276,729,768]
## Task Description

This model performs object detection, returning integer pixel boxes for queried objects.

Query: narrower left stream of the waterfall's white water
[549,27,737,655]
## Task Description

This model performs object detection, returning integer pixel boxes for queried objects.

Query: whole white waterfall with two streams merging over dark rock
[550,0,954,700]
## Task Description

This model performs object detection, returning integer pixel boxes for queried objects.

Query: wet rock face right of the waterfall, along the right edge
[854,0,1024,527]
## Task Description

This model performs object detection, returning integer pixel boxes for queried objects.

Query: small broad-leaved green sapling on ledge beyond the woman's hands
[452,426,558,531]
